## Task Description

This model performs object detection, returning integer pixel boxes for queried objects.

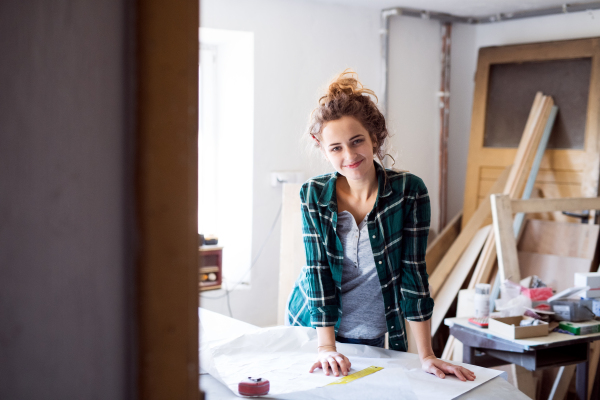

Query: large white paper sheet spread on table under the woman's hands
[200,312,501,400]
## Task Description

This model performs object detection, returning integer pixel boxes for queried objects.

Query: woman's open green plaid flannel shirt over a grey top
[286,163,433,351]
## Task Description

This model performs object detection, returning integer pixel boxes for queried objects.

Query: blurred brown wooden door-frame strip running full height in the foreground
[135,0,200,400]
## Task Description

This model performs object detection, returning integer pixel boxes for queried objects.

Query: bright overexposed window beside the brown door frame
[198,28,254,282]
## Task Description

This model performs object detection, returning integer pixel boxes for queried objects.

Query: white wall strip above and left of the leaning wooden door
[448,11,600,219]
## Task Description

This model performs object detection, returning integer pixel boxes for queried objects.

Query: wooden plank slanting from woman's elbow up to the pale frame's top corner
[429,168,510,298]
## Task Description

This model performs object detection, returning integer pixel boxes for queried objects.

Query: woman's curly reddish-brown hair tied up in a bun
[308,69,389,160]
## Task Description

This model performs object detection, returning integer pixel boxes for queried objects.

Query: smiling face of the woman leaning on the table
[321,116,374,180]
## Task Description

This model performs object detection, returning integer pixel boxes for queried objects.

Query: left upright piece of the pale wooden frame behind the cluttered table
[491,194,521,283]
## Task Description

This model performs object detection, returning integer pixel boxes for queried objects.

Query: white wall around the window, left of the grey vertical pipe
[201,0,380,326]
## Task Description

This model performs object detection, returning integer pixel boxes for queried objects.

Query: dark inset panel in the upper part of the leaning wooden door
[484,57,592,149]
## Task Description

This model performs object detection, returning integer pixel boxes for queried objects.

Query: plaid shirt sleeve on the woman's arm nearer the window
[300,184,339,327]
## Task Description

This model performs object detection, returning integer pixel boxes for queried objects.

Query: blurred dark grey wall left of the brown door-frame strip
[0,0,134,400]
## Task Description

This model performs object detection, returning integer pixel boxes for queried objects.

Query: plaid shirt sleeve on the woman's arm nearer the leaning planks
[400,176,433,321]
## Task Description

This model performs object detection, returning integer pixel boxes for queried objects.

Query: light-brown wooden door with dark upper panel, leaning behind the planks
[462,38,600,227]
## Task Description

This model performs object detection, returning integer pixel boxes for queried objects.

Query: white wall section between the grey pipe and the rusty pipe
[386,17,441,234]
